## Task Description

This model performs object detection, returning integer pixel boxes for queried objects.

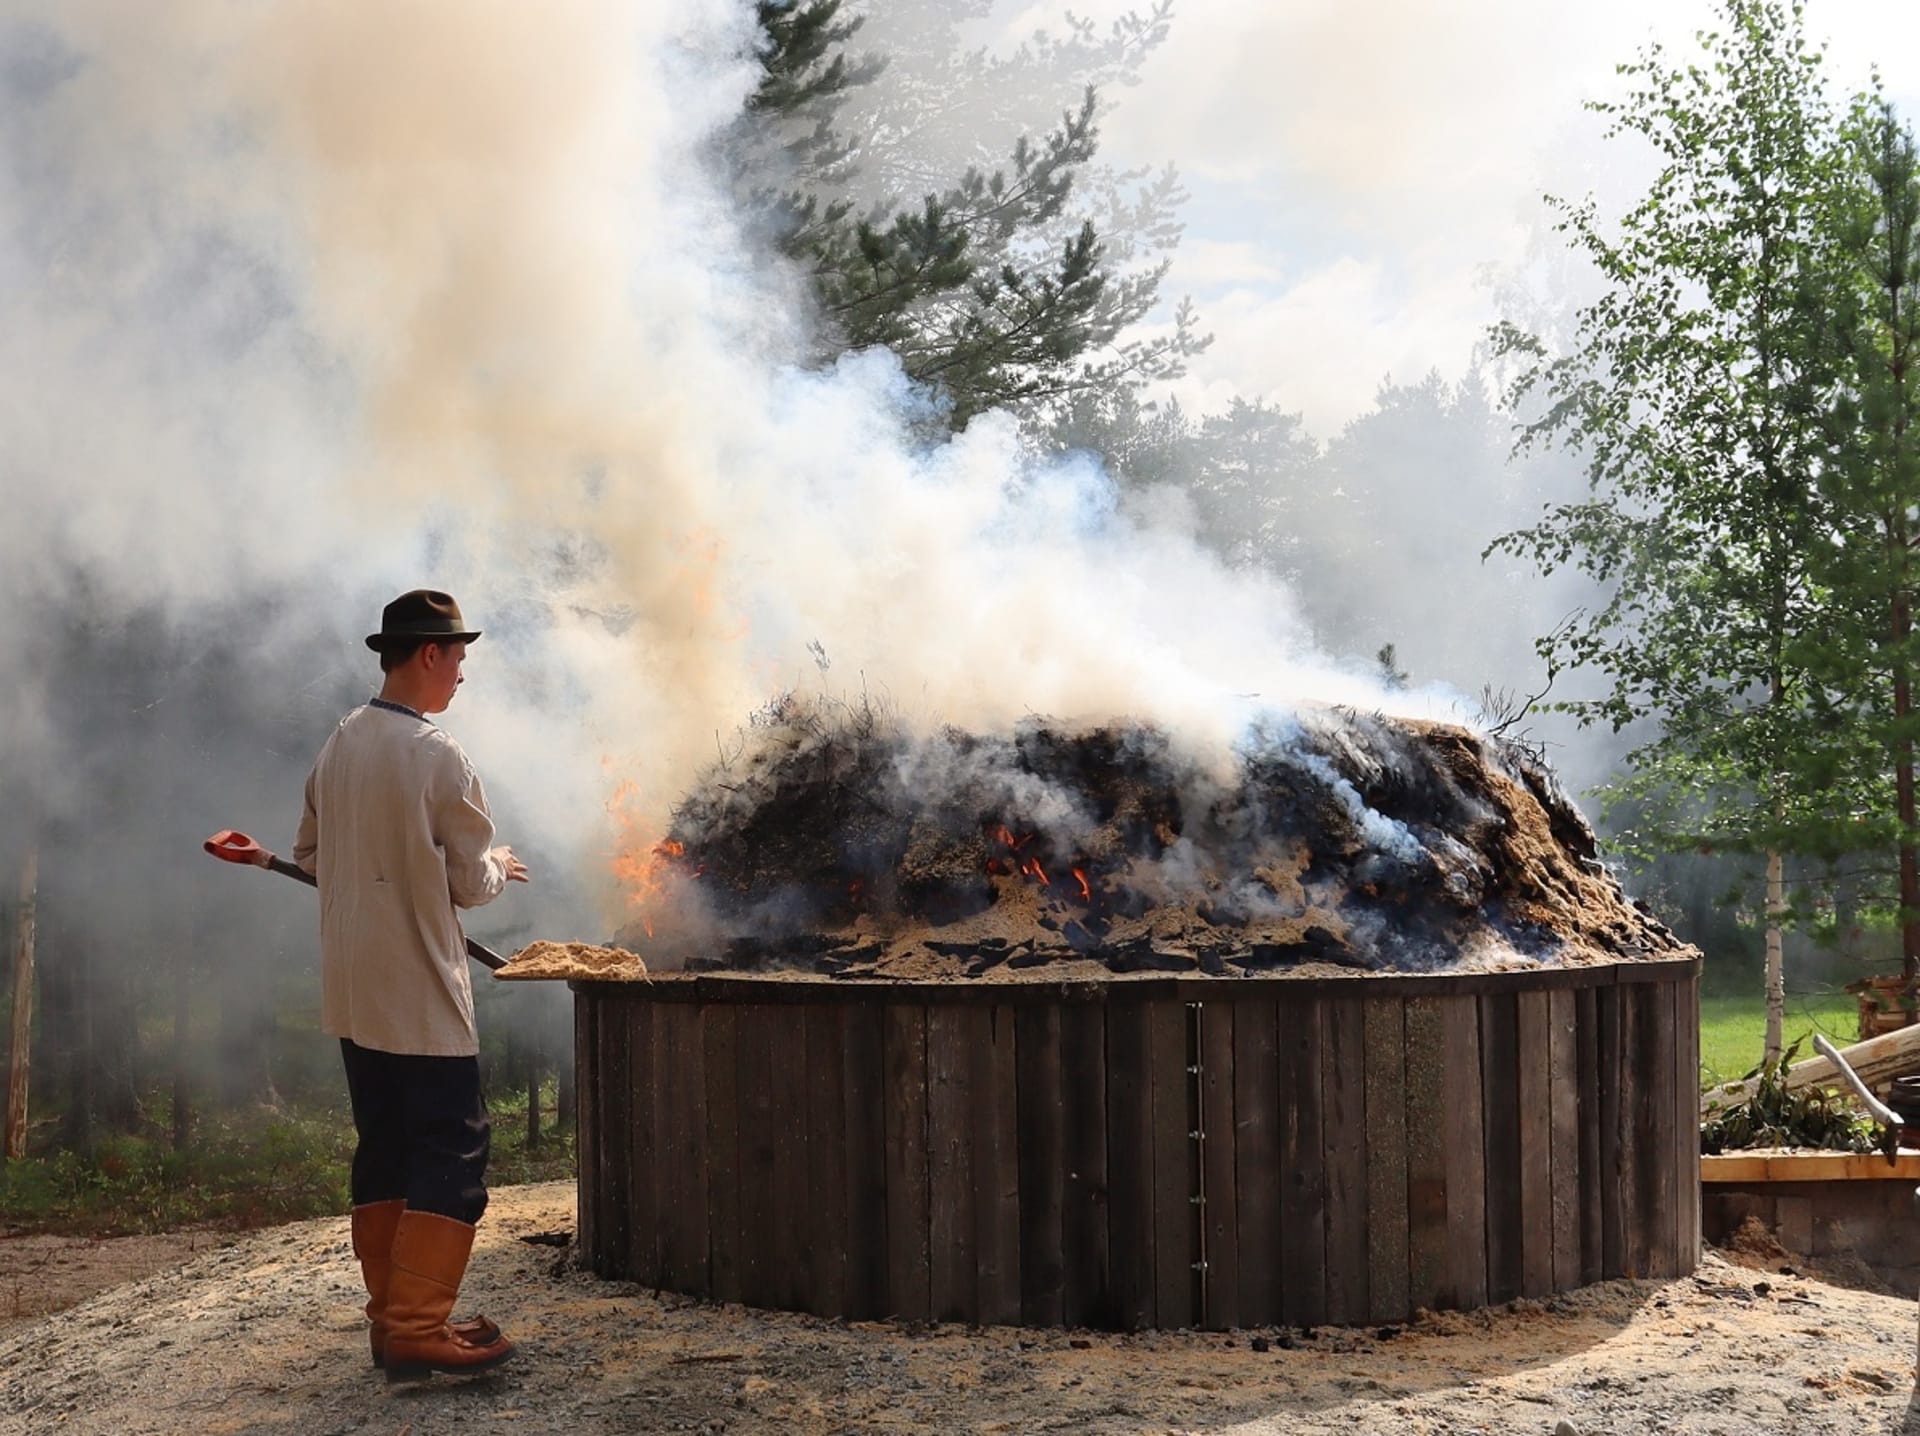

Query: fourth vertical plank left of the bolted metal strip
[1014,1002,1069,1327]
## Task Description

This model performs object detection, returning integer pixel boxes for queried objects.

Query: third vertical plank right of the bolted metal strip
[1279,998,1328,1327]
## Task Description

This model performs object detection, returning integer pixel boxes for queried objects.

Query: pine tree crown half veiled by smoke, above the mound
[726,0,1204,428]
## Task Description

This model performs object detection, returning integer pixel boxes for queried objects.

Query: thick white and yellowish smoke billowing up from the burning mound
[0,0,1446,933]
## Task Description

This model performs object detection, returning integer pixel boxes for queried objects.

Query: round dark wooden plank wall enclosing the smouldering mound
[572,960,1699,1328]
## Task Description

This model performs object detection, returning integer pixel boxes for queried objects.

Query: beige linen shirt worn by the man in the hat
[294,703,507,1058]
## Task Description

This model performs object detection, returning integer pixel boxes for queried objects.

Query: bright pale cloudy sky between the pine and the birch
[1029,0,1920,438]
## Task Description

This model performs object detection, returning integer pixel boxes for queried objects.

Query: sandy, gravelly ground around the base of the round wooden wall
[0,1183,1920,1436]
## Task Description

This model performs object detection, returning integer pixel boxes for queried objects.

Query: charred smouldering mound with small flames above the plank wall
[620,701,1686,977]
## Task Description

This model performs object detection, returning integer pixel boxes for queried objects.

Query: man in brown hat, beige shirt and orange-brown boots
[294,589,528,1382]
